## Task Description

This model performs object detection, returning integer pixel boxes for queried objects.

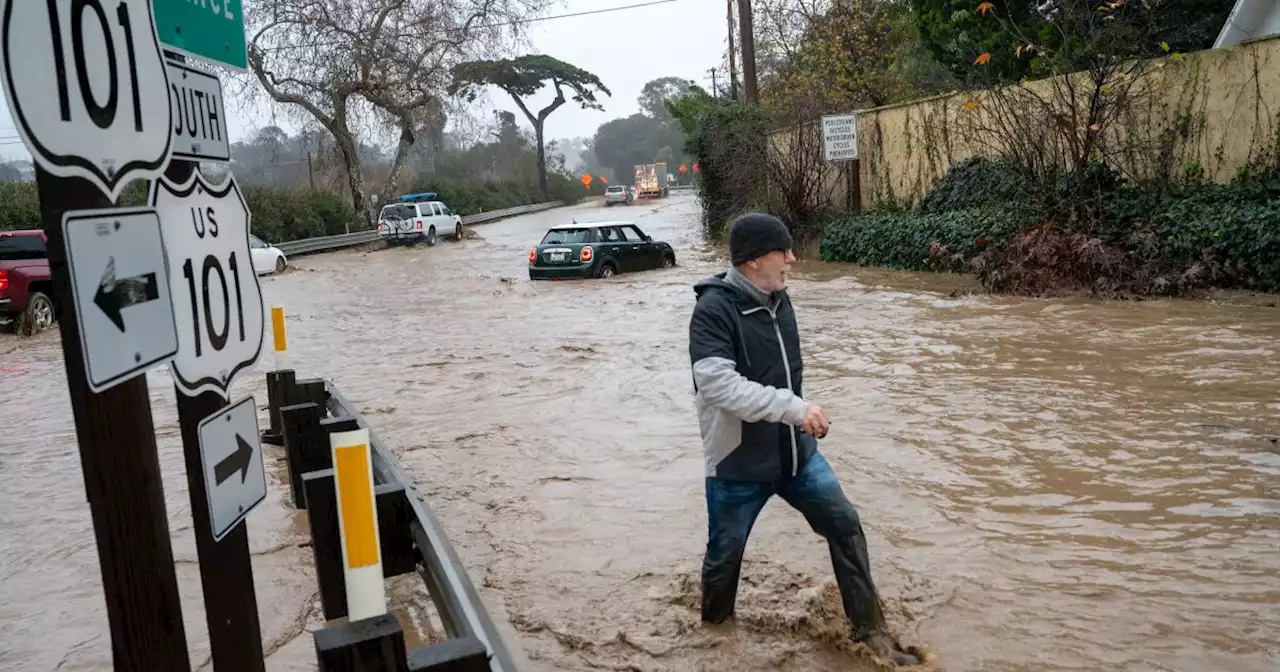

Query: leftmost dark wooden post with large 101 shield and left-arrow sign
[0,0,191,672]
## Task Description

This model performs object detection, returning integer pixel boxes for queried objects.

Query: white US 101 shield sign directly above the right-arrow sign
[151,170,266,398]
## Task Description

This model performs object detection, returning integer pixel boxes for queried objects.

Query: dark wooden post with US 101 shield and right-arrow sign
[157,128,266,672]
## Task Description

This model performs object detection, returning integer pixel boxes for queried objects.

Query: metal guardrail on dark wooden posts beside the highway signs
[262,369,517,672]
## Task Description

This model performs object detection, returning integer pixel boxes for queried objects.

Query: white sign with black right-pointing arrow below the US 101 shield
[200,397,266,541]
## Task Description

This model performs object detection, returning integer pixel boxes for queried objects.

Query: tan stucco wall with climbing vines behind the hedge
[839,33,1280,209]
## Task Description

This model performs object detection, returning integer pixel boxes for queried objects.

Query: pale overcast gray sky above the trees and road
[0,0,728,159]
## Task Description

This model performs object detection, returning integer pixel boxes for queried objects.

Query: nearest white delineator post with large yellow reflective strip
[329,429,387,621]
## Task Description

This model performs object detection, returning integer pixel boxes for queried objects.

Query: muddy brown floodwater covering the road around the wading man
[0,189,1280,672]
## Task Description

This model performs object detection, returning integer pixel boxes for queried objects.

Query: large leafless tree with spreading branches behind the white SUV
[246,0,548,225]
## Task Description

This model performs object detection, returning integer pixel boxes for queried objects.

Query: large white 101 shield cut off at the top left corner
[3,0,173,201]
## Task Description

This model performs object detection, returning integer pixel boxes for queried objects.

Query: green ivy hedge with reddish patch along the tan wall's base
[819,151,1280,294]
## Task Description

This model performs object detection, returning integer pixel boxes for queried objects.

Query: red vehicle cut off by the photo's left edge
[0,229,58,334]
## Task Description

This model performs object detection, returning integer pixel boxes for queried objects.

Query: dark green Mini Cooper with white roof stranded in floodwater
[529,221,676,280]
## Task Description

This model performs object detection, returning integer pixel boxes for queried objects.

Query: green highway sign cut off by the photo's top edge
[151,0,248,70]
